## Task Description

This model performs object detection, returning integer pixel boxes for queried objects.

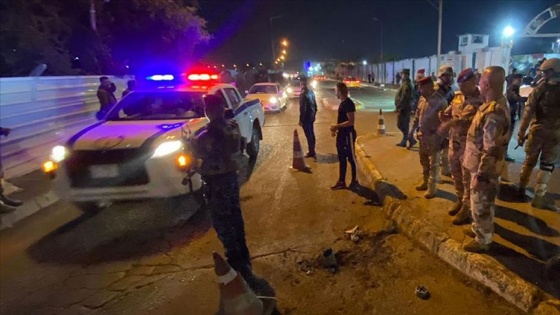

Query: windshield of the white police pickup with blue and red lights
[108,91,204,120]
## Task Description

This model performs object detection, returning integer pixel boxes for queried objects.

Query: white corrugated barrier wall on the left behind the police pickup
[0,76,130,178]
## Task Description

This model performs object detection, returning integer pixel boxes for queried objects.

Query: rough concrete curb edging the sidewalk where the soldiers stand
[355,136,560,315]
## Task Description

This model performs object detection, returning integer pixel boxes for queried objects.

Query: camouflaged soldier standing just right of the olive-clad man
[414,77,447,199]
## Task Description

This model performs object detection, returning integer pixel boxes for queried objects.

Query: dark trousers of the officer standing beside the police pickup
[204,172,252,277]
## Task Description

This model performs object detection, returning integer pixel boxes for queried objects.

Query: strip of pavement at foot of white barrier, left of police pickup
[0,170,59,230]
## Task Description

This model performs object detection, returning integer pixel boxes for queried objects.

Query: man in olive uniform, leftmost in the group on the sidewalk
[395,69,413,147]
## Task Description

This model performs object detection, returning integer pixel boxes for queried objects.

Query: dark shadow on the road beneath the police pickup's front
[27,202,211,265]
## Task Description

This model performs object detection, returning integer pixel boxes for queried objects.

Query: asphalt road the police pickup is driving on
[0,82,520,314]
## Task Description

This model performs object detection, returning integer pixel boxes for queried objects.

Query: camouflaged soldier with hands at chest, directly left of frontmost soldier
[438,68,484,225]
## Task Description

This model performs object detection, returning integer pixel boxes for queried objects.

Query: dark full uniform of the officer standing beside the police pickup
[193,119,251,279]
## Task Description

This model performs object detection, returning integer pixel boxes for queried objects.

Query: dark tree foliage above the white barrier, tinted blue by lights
[0,0,210,76]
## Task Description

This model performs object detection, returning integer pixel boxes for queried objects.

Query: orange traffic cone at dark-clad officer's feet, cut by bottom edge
[212,252,263,315]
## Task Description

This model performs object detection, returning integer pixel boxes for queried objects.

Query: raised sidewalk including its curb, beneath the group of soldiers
[356,133,560,314]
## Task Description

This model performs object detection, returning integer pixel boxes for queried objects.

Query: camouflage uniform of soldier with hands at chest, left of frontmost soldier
[441,89,484,223]
